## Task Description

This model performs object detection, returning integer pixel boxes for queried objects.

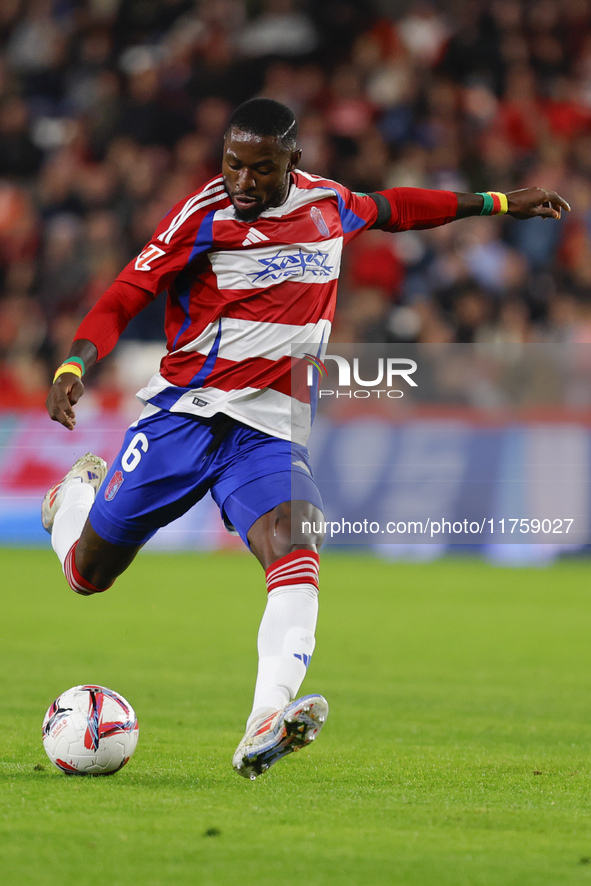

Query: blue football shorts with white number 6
[89,411,323,545]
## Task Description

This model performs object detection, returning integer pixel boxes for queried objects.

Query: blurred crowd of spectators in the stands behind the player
[0,0,591,408]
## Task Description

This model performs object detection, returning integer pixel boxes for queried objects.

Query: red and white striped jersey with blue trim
[118,171,378,443]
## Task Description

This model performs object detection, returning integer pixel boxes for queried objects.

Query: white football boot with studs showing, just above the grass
[232,695,328,781]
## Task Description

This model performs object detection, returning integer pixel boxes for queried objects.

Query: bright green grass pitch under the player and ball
[0,550,591,886]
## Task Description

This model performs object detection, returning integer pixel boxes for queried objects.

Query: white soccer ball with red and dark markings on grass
[43,685,139,775]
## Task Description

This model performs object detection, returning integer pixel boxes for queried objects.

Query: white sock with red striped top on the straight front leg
[247,551,318,728]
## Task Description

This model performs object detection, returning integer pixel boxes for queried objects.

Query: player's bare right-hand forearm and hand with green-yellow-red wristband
[456,188,570,219]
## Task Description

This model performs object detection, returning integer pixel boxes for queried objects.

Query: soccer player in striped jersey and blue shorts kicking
[42,99,570,778]
